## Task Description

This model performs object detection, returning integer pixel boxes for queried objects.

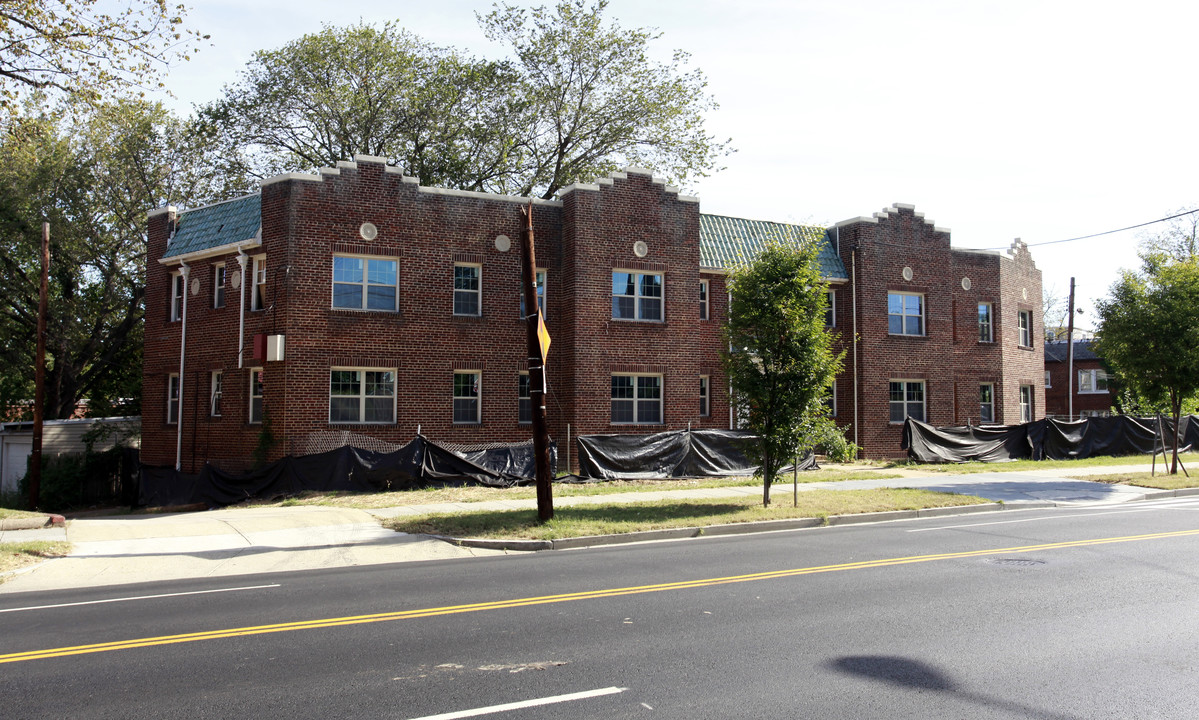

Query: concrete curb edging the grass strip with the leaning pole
[441,502,1011,552]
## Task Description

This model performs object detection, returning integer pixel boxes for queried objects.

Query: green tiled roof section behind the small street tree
[699,214,849,280]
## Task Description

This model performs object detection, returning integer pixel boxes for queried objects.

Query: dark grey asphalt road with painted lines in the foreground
[0,498,1199,720]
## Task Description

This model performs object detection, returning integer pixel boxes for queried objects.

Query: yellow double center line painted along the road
[0,530,1199,662]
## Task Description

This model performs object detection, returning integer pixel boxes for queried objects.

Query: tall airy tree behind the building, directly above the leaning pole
[480,0,728,199]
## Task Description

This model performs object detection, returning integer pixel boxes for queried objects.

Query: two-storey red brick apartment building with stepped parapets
[141,157,1044,472]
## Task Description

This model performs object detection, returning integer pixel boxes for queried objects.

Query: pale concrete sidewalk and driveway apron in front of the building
[0,464,1199,593]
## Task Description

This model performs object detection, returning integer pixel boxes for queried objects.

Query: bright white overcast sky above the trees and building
[154,0,1199,327]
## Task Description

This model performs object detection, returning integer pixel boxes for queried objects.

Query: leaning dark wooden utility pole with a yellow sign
[520,200,554,522]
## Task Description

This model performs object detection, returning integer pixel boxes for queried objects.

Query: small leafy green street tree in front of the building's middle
[723,241,844,506]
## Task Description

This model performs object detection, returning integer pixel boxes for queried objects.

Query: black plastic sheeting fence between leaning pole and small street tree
[578,430,817,480]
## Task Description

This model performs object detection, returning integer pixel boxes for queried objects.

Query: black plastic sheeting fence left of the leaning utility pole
[139,436,558,507]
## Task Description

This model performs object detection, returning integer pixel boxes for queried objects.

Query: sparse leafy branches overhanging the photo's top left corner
[0,0,207,110]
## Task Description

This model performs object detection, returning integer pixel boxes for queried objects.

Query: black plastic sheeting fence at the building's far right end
[902,415,1199,462]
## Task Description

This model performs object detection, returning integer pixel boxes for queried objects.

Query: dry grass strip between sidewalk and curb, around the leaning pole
[384,489,990,540]
